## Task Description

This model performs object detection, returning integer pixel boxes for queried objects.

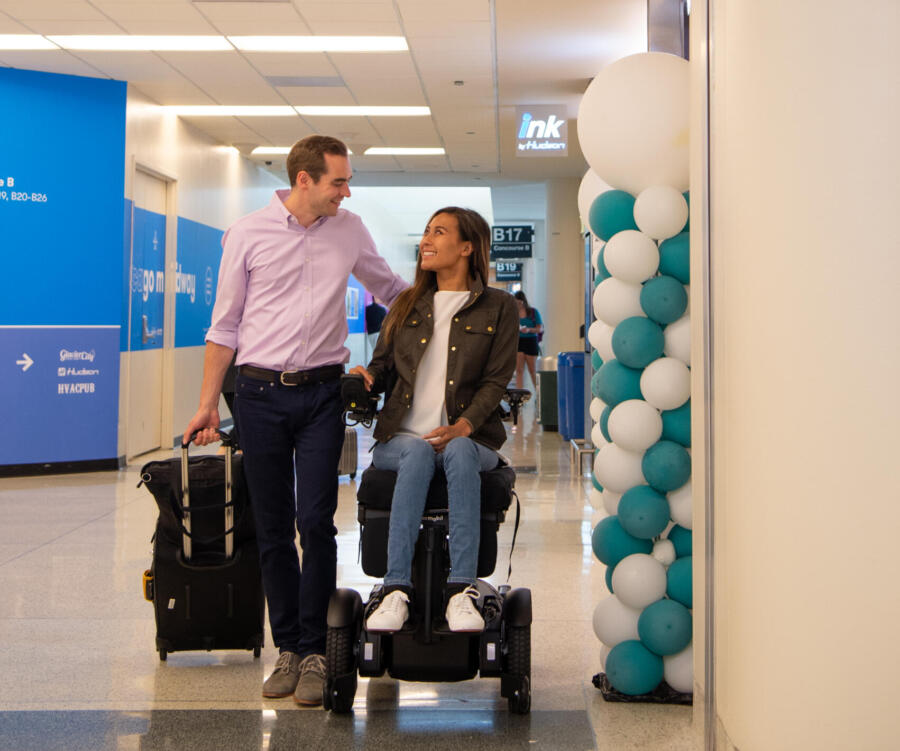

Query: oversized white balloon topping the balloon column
[577,52,691,196]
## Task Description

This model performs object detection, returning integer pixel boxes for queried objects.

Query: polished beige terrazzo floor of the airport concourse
[0,404,703,751]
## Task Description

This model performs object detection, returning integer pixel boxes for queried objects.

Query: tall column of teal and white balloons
[578,52,693,696]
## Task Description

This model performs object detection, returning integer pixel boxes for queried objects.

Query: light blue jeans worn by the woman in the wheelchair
[372,434,499,587]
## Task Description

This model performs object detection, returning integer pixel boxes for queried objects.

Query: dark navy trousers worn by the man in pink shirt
[234,374,344,657]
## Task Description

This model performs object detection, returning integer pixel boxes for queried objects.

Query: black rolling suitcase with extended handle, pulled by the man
[141,433,265,660]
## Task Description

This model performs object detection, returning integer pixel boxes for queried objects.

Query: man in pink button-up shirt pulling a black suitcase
[184,136,407,705]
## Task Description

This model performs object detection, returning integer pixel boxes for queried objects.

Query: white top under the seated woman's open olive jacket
[399,290,469,436]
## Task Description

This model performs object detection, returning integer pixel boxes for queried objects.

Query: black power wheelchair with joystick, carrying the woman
[323,375,531,714]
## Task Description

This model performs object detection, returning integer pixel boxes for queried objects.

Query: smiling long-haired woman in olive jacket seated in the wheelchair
[350,206,519,632]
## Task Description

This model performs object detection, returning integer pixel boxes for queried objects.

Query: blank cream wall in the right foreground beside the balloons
[692,0,900,751]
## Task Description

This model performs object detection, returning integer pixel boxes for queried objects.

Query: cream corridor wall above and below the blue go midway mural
[119,86,286,456]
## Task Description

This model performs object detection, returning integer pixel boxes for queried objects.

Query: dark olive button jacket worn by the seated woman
[367,279,519,450]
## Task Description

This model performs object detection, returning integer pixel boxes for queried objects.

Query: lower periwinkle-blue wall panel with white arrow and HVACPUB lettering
[0,326,119,464]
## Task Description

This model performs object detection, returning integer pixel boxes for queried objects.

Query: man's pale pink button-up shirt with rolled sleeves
[206,190,408,370]
